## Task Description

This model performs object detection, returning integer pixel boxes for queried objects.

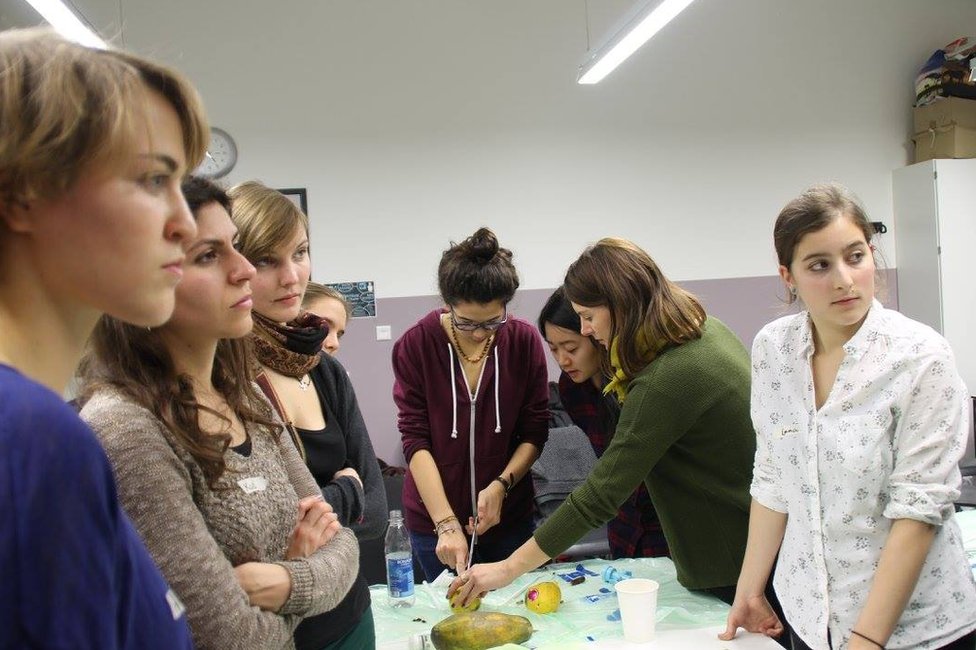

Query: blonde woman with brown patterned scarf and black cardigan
[229,181,387,650]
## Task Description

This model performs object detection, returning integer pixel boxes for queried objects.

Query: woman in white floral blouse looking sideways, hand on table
[720,185,976,650]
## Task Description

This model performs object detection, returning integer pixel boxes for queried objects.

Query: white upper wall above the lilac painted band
[32,0,976,298]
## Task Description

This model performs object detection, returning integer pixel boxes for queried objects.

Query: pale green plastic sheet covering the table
[370,558,729,650]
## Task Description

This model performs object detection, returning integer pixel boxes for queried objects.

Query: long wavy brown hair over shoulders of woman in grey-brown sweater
[80,316,281,489]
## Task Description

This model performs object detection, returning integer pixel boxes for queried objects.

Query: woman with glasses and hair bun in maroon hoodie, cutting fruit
[393,228,549,580]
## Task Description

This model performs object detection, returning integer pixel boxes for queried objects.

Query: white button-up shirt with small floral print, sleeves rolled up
[751,301,976,650]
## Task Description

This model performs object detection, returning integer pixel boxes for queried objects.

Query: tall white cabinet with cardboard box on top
[892,159,976,394]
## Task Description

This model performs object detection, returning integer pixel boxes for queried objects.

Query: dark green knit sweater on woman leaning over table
[535,317,756,589]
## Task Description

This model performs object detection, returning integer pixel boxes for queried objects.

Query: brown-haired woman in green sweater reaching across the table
[451,239,780,624]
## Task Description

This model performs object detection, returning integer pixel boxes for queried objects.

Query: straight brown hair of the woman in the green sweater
[563,237,705,377]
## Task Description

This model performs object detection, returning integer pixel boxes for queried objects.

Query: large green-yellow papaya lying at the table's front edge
[430,612,532,650]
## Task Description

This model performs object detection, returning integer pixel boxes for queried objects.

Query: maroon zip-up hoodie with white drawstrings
[393,310,549,543]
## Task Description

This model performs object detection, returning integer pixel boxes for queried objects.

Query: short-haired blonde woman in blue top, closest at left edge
[0,29,207,649]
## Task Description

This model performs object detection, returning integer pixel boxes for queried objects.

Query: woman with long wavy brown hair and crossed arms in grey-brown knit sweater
[81,178,358,648]
